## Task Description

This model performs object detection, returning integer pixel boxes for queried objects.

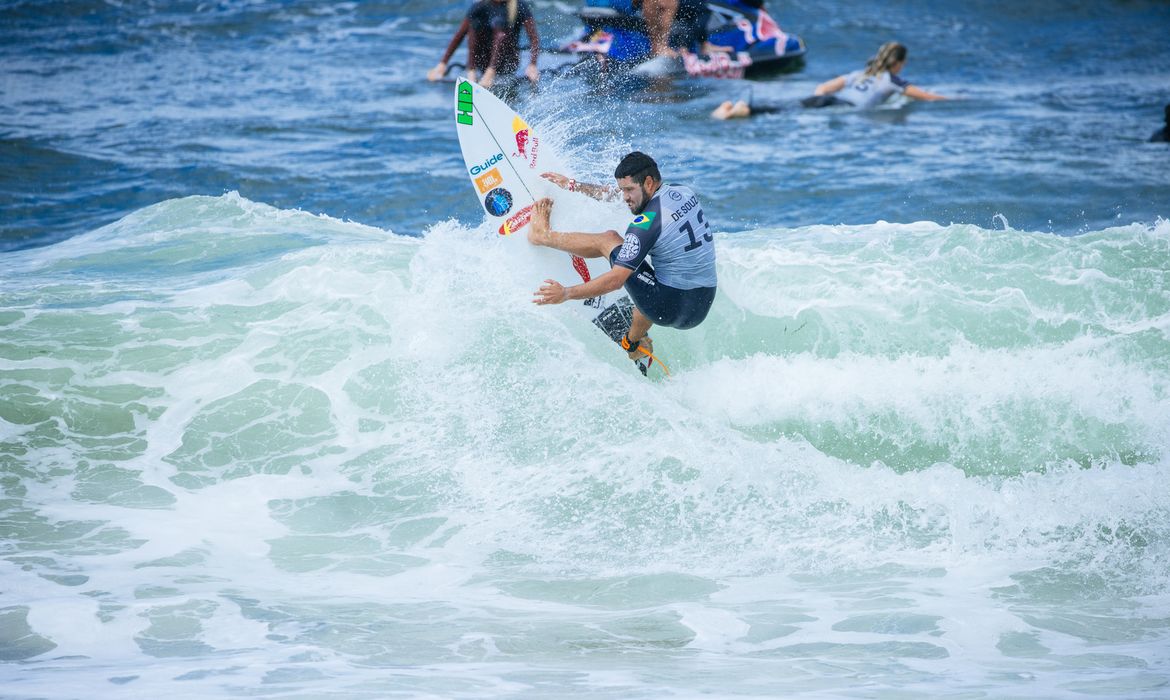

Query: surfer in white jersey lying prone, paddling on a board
[711,41,949,119]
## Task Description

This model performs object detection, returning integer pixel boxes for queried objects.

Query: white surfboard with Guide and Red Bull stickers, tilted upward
[455,78,653,375]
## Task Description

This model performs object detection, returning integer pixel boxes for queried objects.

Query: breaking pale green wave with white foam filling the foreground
[0,194,1170,698]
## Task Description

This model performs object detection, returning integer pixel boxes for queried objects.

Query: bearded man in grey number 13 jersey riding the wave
[528,151,716,359]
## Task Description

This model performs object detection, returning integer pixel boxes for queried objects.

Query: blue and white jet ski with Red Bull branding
[559,0,807,78]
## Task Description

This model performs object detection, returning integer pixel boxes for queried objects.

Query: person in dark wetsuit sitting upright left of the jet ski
[427,0,541,88]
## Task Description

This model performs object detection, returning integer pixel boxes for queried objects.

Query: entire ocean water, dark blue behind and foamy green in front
[0,0,1170,699]
